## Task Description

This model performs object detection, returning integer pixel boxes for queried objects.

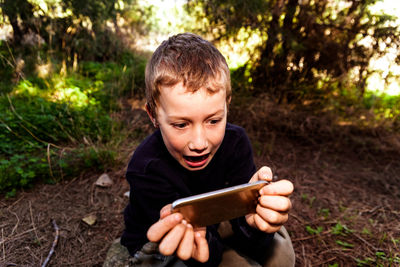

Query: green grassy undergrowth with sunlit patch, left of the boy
[0,55,145,197]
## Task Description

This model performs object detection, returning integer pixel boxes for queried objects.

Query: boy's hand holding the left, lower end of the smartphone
[147,204,209,262]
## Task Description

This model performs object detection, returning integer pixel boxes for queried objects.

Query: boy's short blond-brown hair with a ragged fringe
[146,33,232,116]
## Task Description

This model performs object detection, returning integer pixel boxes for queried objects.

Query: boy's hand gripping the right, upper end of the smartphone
[246,166,293,233]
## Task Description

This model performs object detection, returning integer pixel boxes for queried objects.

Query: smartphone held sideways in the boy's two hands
[172,181,268,227]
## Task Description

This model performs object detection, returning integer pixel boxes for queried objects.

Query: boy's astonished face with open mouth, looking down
[152,83,227,171]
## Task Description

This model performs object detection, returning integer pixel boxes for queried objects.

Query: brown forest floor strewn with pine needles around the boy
[0,97,400,266]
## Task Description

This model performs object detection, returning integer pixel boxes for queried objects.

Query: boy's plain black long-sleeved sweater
[121,123,272,266]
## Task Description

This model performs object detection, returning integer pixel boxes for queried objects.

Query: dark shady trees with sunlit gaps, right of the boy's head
[187,0,400,129]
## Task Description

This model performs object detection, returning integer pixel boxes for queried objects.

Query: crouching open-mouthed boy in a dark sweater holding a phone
[121,33,294,266]
